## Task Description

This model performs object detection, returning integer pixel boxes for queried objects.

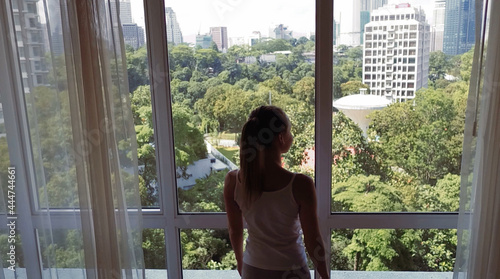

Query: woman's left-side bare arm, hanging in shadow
[224,171,243,276]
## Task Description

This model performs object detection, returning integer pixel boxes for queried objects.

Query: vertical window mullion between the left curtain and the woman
[144,0,182,278]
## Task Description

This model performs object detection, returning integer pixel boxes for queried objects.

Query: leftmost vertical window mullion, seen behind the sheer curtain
[0,1,42,278]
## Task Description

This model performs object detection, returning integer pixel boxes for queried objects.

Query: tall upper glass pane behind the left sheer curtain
[8,0,154,208]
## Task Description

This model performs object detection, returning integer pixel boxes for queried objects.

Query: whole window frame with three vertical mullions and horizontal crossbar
[0,0,458,278]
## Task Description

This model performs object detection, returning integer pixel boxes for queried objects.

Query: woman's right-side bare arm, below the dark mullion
[293,174,330,279]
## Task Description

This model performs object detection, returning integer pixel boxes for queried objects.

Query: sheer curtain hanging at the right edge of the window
[454,0,500,279]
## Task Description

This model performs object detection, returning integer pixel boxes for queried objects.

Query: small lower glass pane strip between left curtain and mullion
[142,229,167,278]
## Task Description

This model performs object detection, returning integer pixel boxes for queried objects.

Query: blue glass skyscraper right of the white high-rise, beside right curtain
[443,0,476,55]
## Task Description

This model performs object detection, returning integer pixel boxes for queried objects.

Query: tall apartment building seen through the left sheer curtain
[11,0,49,93]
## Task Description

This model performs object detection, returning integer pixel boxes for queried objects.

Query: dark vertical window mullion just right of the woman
[315,0,333,278]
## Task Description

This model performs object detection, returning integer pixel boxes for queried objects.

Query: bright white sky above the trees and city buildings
[130,0,434,43]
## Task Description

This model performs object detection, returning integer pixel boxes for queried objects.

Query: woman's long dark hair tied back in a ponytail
[240,106,290,206]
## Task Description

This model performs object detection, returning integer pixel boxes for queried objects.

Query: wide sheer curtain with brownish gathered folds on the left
[0,0,144,278]
